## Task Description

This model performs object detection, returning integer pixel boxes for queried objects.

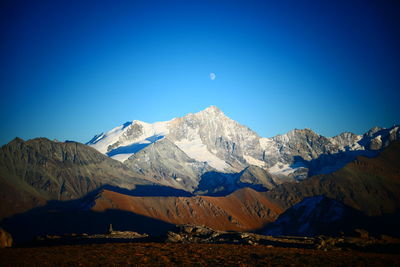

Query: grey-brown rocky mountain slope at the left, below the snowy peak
[0,138,155,218]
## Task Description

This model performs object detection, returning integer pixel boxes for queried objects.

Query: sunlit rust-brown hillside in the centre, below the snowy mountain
[92,188,282,231]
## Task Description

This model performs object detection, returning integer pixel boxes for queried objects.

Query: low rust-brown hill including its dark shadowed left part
[0,188,282,245]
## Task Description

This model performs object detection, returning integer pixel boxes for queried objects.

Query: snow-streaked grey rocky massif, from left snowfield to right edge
[87,106,400,191]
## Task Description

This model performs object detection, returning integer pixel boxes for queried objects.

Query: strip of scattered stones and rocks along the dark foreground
[23,225,400,253]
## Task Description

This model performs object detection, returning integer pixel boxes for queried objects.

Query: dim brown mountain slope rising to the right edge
[266,141,400,216]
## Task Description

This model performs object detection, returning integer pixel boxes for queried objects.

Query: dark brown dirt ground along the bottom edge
[0,243,400,267]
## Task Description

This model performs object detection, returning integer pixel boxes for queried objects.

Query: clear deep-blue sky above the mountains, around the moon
[0,0,400,147]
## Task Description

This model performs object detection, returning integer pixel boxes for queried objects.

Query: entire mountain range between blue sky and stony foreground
[0,106,400,243]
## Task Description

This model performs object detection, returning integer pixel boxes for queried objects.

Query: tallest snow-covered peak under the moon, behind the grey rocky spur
[87,106,263,172]
